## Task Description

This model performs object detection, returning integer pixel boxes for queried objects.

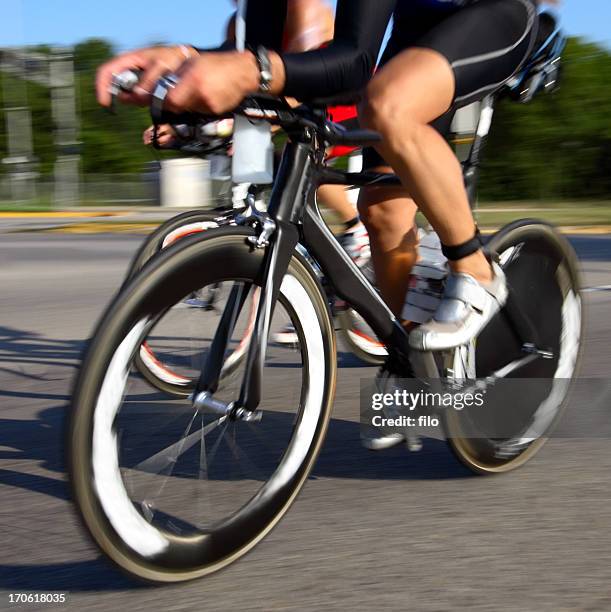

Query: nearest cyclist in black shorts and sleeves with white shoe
[97,0,538,358]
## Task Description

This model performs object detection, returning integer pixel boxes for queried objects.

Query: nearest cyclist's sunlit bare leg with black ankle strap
[361,48,492,282]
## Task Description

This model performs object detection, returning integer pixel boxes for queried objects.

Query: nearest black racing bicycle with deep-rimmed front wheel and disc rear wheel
[68,14,583,582]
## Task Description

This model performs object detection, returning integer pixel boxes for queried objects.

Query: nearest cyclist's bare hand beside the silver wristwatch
[165,51,259,115]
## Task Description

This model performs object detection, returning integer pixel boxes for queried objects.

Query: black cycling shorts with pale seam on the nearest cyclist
[363,0,538,168]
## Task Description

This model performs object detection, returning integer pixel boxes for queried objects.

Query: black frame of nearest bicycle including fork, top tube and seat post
[196,96,537,412]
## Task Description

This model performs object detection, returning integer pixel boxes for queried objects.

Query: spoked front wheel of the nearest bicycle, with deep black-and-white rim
[68,228,336,582]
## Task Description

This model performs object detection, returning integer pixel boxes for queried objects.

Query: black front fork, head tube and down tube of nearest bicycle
[230,141,426,411]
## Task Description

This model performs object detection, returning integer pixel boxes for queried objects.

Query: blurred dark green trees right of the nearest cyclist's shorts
[481,38,611,200]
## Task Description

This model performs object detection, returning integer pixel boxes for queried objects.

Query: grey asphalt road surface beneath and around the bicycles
[0,234,611,612]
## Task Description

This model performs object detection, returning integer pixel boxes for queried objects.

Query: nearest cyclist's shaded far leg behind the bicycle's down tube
[359,172,418,316]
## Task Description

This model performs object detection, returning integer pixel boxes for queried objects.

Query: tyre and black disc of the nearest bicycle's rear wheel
[443,219,584,474]
